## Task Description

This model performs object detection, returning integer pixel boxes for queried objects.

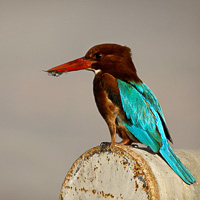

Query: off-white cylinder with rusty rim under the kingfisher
[60,145,200,200]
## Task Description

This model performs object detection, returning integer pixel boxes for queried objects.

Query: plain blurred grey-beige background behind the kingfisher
[0,0,200,200]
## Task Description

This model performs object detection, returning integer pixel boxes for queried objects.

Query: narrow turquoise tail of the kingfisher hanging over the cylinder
[160,145,196,184]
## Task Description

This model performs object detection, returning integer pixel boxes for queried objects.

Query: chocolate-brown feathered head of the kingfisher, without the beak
[85,44,141,82]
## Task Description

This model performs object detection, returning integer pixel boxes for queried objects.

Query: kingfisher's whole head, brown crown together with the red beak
[47,44,140,81]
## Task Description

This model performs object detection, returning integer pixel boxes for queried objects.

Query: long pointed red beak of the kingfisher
[47,57,94,76]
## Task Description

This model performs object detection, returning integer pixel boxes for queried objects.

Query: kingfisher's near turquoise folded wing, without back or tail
[117,79,162,152]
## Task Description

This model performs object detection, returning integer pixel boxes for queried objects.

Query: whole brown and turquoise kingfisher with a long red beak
[46,43,196,185]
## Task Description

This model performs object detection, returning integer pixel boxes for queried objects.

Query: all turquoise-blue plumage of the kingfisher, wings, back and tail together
[117,79,196,184]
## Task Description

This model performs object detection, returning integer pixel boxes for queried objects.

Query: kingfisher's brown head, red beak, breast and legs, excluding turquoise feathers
[47,43,142,147]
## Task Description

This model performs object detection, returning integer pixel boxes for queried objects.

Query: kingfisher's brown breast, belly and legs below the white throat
[93,72,138,147]
